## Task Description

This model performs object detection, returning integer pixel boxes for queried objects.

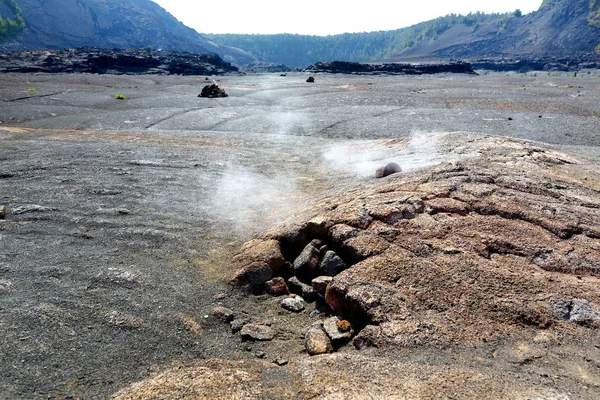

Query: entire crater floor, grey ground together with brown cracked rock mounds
[0,71,600,399]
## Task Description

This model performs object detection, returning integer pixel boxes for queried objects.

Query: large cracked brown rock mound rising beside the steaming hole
[232,133,600,346]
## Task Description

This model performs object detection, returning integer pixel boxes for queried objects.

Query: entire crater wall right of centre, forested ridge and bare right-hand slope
[211,0,600,69]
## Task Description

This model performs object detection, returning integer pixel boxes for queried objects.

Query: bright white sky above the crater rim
[153,0,542,35]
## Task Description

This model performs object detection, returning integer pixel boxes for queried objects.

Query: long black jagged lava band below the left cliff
[0,48,238,75]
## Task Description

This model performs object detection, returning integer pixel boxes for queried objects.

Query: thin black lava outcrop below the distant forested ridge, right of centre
[304,61,475,75]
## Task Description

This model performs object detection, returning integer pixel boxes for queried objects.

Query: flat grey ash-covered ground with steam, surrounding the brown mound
[0,71,600,399]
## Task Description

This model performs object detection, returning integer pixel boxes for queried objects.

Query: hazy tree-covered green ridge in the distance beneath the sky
[205,12,518,67]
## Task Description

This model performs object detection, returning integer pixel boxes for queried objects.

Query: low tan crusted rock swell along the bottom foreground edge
[112,346,600,400]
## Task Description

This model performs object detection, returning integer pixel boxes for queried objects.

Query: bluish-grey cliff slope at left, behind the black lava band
[0,0,254,63]
